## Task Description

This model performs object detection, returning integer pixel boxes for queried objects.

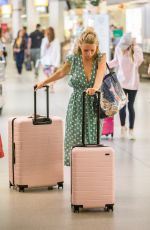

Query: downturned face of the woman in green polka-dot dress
[80,43,97,60]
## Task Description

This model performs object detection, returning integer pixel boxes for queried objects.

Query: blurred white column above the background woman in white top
[49,0,65,42]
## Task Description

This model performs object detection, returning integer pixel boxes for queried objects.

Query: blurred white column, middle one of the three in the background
[26,0,39,33]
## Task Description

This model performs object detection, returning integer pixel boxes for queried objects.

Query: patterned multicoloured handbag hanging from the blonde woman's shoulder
[93,63,128,118]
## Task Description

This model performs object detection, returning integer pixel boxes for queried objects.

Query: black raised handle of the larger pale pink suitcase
[33,85,52,125]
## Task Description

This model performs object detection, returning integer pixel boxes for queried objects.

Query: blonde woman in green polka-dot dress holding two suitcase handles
[37,27,106,166]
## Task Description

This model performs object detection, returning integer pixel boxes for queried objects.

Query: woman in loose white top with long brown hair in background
[41,27,61,92]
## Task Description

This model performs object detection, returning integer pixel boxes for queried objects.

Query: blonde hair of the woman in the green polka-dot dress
[73,27,99,54]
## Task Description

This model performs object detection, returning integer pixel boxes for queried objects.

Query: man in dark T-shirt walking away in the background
[28,24,44,76]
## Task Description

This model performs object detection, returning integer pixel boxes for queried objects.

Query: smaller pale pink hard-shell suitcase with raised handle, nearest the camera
[71,92,115,212]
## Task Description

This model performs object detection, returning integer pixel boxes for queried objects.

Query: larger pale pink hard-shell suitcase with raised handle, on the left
[8,86,64,191]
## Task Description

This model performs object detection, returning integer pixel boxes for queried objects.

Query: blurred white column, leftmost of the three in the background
[12,0,22,38]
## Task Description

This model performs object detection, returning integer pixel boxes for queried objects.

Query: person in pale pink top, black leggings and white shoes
[108,33,143,140]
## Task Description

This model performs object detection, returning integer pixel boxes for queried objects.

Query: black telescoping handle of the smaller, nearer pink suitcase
[82,91,100,145]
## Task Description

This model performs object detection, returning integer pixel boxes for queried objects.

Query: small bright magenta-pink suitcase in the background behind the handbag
[102,117,114,137]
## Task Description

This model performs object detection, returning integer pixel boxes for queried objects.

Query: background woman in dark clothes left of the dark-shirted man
[13,30,26,74]
